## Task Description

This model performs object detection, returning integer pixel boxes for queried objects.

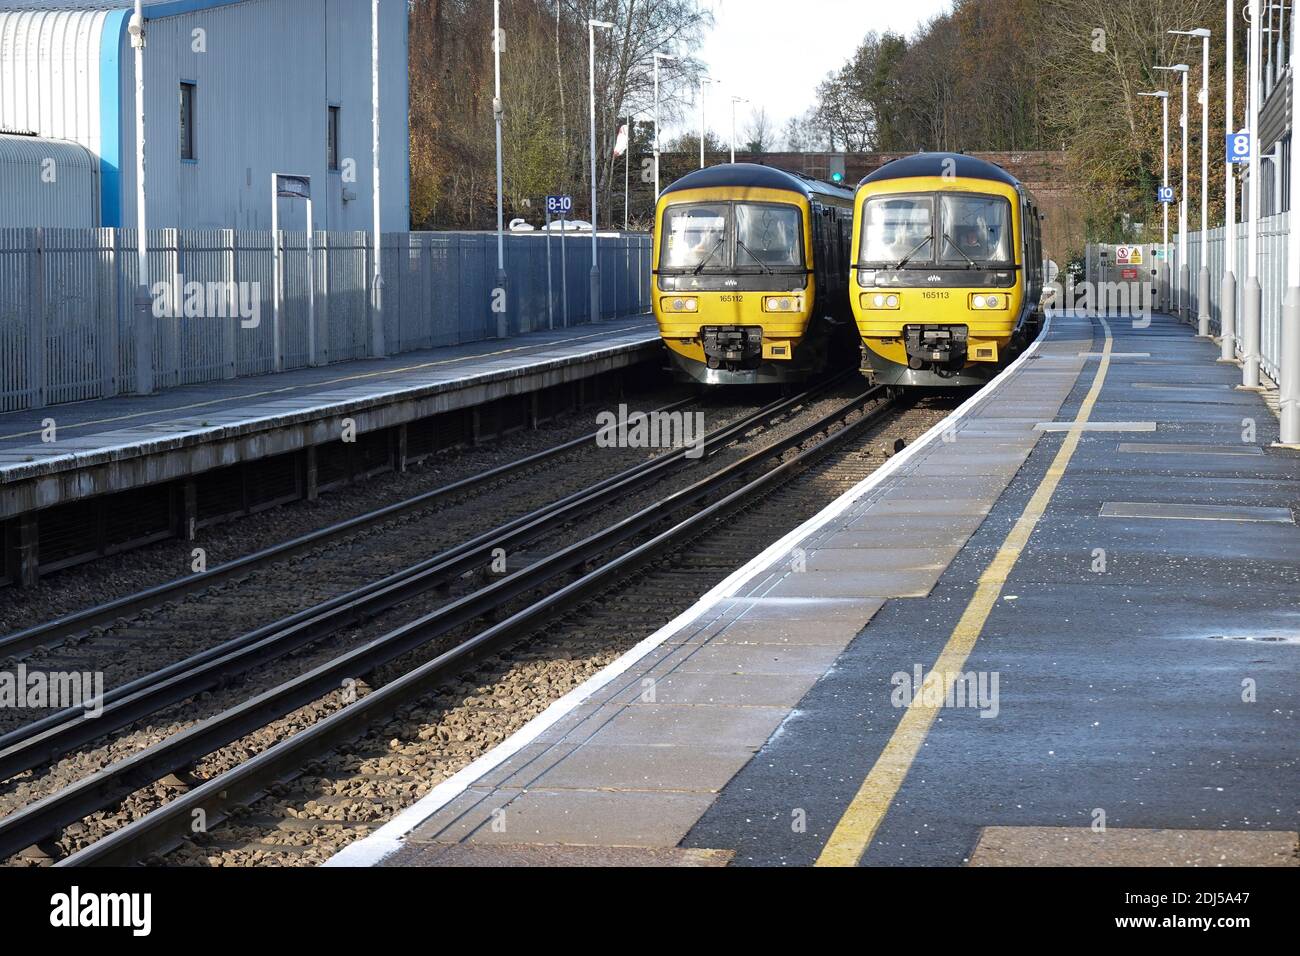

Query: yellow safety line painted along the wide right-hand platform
[816,319,1113,866]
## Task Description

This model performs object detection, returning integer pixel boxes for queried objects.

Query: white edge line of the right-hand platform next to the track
[322,316,1074,866]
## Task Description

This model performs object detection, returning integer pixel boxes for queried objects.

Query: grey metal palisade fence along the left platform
[0,229,650,411]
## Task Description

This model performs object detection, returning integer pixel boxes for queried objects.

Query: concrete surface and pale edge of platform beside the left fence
[0,316,662,518]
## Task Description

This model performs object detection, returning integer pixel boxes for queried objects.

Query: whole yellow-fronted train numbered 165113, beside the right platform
[850,153,1043,389]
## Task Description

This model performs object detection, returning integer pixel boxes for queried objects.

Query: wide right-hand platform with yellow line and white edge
[332,315,1300,866]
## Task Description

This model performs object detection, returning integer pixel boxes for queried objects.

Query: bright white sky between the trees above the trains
[683,0,952,139]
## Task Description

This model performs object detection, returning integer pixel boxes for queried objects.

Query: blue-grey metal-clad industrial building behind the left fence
[0,0,410,230]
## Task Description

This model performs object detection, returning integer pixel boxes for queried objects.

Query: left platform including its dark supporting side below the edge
[0,323,662,583]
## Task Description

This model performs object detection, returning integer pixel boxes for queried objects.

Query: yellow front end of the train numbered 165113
[850,177,1024,386]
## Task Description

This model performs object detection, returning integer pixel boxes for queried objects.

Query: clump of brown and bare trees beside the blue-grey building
[408,0,710,228]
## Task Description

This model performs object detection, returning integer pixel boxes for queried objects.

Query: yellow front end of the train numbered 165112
[653,187,815,384]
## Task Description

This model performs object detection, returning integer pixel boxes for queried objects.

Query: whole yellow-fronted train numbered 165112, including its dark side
[653,163,859,385]
